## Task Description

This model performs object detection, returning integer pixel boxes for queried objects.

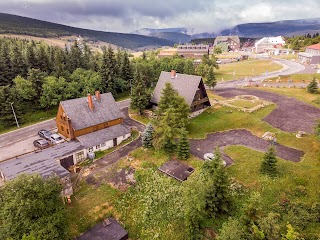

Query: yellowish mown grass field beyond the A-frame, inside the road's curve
[216,60,282,81]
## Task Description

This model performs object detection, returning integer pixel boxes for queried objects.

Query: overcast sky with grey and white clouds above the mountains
[0,0,320,33]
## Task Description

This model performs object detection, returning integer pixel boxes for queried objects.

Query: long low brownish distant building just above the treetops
[177,44,209,59]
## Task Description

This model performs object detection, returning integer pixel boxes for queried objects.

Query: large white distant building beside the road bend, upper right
[254,36,286,53]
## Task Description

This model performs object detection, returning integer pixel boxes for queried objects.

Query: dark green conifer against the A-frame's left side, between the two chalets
[130,71,150,115]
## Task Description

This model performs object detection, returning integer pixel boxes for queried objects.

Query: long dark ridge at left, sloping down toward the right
[0,13,175,49]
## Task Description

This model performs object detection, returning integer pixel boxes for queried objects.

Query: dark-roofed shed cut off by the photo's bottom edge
[77,218,128,240]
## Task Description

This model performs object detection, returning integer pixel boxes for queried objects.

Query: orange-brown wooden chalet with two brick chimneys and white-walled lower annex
[56,91,131,152]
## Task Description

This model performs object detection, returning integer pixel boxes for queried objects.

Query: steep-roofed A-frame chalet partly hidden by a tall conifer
[151,70,211,115]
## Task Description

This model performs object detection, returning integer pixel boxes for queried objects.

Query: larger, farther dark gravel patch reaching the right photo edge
[216,88,320,133]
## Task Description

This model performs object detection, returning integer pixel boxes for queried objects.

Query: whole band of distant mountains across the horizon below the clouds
[0,13,320,50]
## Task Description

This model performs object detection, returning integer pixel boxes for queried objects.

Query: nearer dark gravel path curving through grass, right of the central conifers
[190,130,304,165]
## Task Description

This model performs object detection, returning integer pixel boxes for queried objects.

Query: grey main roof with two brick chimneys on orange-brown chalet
[60,93,123,130]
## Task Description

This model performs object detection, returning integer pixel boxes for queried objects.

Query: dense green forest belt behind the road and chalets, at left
[0,38,214,130]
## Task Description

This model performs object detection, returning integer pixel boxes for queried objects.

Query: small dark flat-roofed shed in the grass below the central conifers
[159,160,194,182]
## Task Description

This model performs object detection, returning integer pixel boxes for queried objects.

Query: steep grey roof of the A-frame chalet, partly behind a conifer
[151,72,202,106]
